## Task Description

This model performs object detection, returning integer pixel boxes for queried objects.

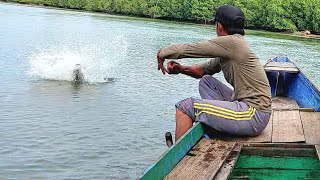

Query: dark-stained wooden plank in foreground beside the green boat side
[166,138,235,180]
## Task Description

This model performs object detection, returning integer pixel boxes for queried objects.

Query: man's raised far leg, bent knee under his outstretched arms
[199,75,233,101]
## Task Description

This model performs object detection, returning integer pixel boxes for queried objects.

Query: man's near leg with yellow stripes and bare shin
[176,98,270,140]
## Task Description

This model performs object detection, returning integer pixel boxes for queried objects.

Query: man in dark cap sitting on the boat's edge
[157,5,271,140]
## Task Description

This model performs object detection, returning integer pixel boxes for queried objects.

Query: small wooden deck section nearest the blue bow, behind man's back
[272,97,299,110]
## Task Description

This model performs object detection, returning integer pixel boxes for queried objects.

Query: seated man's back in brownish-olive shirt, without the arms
[214,34,271,111]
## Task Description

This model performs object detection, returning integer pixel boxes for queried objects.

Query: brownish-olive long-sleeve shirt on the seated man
[159,34,271,112]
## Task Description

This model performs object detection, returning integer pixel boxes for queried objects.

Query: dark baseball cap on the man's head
[213,5,245,29]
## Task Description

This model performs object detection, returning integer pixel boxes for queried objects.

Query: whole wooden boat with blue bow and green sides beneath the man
[140,57,320,180]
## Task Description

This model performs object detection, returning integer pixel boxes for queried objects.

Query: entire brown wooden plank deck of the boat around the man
[166,97,320,180]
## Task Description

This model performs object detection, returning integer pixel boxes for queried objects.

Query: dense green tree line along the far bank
[4,0,320,34]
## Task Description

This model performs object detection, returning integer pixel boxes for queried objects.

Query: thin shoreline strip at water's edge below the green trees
[0,0,320,40]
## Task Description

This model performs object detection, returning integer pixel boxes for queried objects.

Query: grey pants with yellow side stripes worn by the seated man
[176,75,271,136]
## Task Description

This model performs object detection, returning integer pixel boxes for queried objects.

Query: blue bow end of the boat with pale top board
[265,57,320,112]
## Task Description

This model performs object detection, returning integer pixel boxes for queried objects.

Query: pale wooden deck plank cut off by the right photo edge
[300,112,320,144]
